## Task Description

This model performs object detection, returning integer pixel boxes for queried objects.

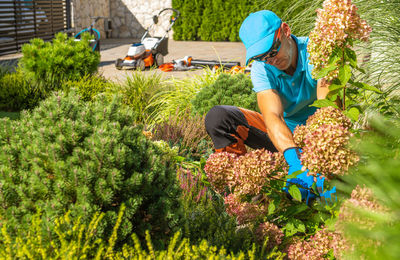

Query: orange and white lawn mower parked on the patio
[115,8,180,70]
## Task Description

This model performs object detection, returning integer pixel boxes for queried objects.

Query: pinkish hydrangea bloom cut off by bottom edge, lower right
[288,228,347,260]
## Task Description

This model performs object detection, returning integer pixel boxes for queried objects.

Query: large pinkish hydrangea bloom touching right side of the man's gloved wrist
[294,107,358,178]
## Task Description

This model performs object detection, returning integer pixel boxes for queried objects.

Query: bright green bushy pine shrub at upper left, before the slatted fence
[19,33,100,97]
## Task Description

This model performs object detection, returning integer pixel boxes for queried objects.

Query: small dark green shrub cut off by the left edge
[0,69,39,111]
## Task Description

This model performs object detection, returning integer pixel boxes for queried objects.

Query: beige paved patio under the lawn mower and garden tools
[0,39,246,81]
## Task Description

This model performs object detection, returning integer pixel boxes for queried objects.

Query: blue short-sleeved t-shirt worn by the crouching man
[251,35,317,132]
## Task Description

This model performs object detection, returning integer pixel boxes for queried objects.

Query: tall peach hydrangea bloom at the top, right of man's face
[307,0,372,80]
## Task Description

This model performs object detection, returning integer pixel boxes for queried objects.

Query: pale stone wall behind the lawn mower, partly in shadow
[72,0,172,39]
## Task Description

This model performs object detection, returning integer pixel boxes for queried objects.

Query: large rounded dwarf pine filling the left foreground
[0,92,180,248]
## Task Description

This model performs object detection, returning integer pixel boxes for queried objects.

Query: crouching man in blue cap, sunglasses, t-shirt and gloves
[205,10,336,201]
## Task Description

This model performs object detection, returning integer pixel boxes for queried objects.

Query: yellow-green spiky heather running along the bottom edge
[0,205,284,259]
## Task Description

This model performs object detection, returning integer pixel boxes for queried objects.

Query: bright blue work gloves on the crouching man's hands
[283,147,336,204]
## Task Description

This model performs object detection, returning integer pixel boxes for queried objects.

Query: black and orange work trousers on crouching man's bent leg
[205,106,278,155]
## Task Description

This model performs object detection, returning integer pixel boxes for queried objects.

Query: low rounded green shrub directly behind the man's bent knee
[192,73,258,115]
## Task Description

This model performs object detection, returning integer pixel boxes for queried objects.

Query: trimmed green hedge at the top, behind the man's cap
[172,0,260,41]
